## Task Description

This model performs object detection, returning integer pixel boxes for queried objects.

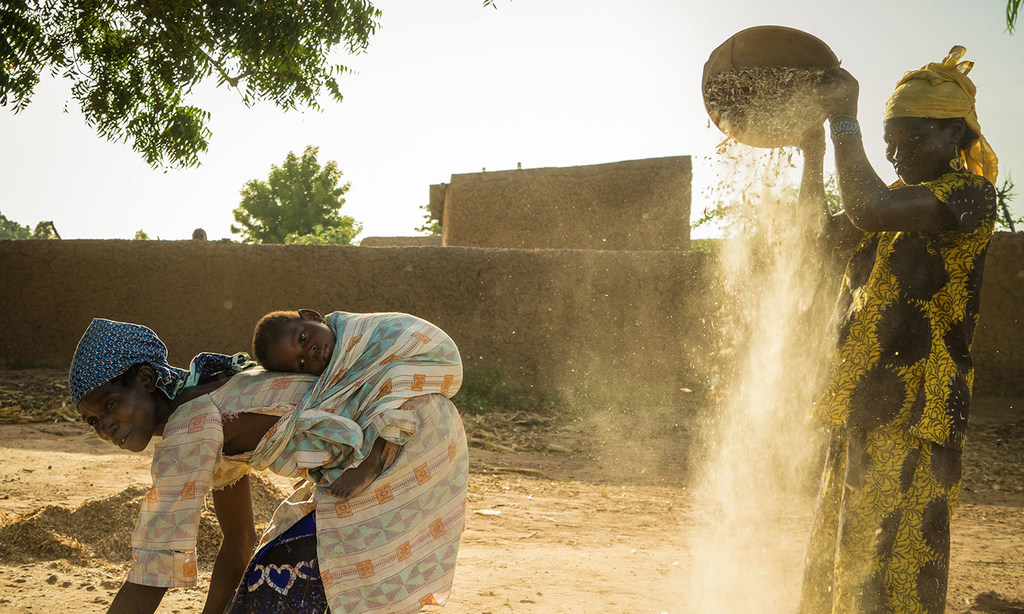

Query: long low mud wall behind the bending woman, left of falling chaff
[0,240,713,407]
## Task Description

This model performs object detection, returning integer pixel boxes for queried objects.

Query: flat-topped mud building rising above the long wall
[430,156,691,251]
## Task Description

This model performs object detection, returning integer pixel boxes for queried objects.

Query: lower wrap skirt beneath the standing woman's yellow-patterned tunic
[834,426,959,614]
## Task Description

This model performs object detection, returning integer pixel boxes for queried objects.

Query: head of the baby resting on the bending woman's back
[253,309,335,376]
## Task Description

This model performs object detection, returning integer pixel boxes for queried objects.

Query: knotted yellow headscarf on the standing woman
[885,45,999,183]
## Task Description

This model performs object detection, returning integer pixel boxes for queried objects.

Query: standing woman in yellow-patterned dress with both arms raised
[800,46,997,613]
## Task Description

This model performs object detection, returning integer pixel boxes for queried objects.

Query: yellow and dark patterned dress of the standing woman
[801,172,996,613]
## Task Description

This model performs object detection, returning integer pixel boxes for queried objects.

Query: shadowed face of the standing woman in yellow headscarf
[885,118,964,185]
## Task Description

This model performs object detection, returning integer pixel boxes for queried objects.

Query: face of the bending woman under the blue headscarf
[78,366,167,452]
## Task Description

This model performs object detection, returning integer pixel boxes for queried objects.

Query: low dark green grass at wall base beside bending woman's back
[455,366,566,413]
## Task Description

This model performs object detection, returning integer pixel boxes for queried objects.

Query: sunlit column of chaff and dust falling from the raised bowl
[689,141,830,614]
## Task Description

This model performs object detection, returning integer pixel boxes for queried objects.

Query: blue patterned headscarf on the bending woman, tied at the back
[68,317,254,406]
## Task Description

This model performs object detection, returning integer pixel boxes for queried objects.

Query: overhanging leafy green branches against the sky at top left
[0,0,381,166]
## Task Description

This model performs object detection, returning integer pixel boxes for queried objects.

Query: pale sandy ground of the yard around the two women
[0,372,1024,614]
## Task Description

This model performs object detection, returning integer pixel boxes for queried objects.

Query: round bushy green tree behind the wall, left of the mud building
[231,145,362,245]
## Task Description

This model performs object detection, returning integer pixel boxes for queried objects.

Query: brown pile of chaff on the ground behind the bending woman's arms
[0,474,285,567]
